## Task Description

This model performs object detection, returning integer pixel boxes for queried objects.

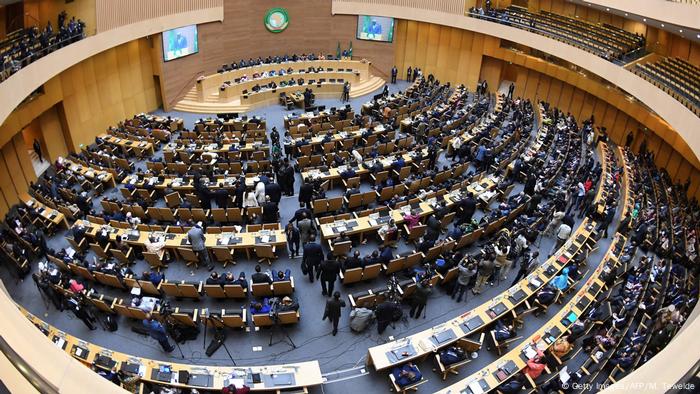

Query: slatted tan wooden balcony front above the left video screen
[95,0,224,33]
